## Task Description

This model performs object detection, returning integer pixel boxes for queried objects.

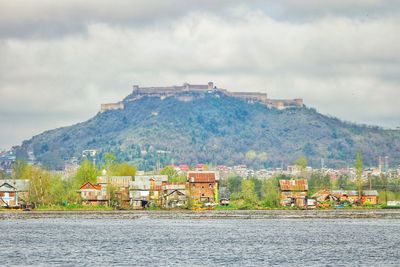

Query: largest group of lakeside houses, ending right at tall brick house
[78,171,219,209]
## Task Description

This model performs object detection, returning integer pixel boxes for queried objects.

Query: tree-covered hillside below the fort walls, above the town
[18,90,400,169]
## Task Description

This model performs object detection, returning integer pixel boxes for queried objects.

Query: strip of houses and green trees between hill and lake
[0,151,400,210]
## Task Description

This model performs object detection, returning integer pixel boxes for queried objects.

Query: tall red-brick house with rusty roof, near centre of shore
[187,171,219,203]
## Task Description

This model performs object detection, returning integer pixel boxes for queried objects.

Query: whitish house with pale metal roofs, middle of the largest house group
[129,175,168,209]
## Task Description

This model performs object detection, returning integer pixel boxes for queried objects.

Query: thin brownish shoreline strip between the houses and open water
[0,209,400,220]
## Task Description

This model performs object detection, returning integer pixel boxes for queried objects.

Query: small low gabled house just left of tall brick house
[161,183,189,208]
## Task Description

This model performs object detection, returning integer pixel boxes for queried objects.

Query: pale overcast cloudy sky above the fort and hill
[0,0,400,149]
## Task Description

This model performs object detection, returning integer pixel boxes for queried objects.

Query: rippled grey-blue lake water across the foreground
[0,217,400,266]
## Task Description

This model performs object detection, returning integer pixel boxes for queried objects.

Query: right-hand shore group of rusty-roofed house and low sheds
[279,179,378,208]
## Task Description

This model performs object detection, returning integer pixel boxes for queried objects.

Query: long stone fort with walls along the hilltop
[100,82,304,112]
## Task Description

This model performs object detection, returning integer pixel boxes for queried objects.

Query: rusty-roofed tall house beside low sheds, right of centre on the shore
[279,179,308,207]
